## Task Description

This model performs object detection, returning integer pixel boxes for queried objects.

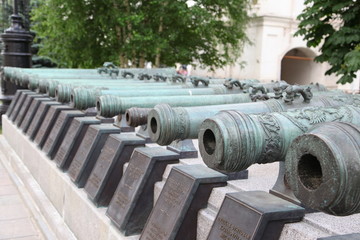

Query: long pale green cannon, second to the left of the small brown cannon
[70,86,241,109]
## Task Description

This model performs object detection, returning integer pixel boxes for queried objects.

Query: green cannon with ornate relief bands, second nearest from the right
[198,105,360,172]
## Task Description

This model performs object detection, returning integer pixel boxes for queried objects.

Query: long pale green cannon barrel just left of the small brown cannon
[96,93,251,117]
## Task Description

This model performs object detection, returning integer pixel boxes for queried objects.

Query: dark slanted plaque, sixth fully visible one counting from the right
[54,117,100,171]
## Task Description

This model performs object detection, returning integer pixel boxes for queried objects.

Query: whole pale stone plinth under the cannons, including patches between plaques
[0,116,360,240]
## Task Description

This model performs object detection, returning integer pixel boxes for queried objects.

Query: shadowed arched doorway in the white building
[280,48,321,85]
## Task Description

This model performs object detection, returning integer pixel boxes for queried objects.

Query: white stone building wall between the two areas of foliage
[192,0,348,89]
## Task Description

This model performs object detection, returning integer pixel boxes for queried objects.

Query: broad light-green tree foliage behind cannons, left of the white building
[32,0,249,68]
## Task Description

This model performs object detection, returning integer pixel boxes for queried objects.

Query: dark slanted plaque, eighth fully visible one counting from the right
[34,105,73,149]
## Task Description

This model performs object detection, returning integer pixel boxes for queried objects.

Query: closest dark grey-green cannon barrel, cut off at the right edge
[285,122,360,216]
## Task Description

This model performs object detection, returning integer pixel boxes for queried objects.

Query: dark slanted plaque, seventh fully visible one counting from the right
[43,110,85,159]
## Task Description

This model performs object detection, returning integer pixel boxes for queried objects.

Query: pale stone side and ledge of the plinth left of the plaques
[0,115,139,240]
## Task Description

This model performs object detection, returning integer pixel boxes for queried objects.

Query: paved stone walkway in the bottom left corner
[0,161,44,240]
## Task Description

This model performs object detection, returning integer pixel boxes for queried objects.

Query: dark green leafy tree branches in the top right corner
[295,0,360,84]
